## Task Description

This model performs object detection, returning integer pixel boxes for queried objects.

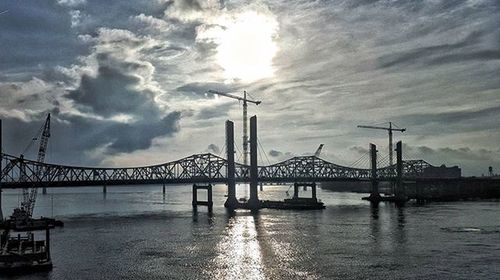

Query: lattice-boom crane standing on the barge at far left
[12,113,50,220]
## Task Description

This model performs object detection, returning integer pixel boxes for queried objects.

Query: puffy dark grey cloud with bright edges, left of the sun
[60,34,180,154]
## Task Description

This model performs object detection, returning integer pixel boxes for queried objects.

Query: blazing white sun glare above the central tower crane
[216,11,278,82]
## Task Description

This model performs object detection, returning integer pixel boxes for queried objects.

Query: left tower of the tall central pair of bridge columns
[224,120,238,209]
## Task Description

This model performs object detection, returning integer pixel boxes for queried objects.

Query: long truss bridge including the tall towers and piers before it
[0,116,440,209]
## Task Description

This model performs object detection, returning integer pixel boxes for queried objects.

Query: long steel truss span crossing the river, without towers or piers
[0,153,431,189]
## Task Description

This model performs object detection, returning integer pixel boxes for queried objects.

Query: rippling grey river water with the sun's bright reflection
[3,185,500,279]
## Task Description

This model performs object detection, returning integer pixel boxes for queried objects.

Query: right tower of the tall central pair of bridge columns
[248,116,260,210]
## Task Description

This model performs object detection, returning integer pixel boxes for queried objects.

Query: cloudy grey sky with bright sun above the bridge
[0,0,500,175]
